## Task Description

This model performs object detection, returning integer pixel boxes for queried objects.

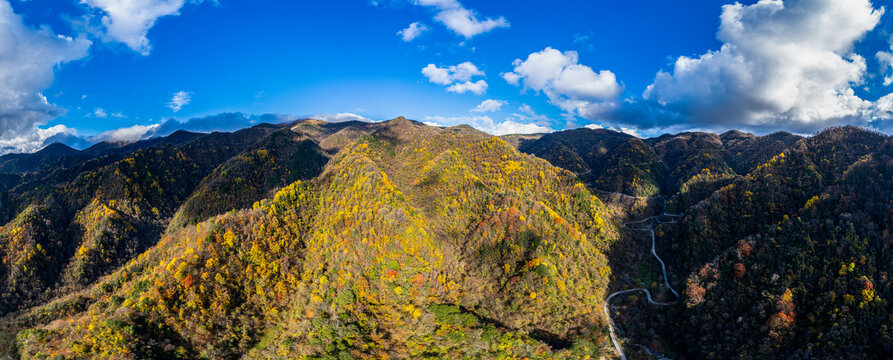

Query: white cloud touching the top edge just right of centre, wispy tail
[415,0,509,39]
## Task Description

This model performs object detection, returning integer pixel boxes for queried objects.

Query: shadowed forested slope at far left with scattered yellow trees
[0,124,282,314]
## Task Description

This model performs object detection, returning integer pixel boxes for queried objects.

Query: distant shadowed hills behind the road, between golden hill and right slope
[518,128,801,211]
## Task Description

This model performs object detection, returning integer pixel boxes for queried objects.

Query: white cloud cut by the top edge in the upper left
[81,0,201,55]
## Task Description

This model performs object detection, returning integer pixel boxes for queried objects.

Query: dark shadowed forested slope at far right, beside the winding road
[648,127,893,359]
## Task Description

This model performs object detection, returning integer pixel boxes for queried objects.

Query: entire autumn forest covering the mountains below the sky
[0,118,893,359]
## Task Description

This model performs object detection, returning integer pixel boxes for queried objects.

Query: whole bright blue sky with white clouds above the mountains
[0,0,893,154]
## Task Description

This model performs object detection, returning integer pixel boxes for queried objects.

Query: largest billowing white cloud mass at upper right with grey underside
[643,0,884,131]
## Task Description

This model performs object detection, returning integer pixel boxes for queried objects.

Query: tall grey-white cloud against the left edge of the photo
[0,0,91,154]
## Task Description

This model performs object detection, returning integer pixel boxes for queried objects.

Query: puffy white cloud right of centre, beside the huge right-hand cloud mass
[502,47,623,118]
